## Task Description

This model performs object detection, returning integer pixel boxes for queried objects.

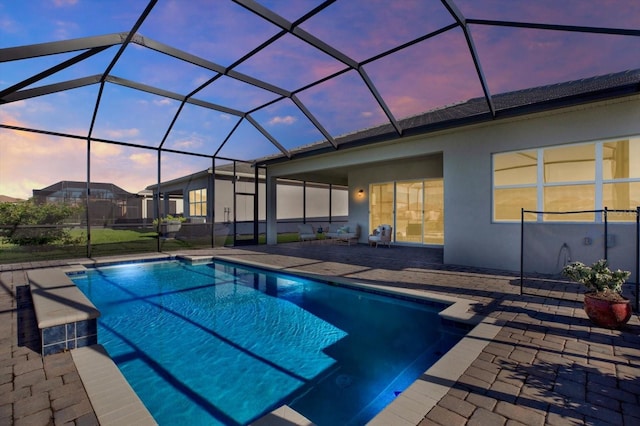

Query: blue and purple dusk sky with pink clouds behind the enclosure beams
[0,0,640,199]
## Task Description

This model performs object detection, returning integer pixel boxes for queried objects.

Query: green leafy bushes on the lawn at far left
[0,199,82,246]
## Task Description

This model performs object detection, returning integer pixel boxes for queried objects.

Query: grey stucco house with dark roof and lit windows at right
[258,70,640,273]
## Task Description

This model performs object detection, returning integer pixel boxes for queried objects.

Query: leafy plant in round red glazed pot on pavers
[562,259,631,328]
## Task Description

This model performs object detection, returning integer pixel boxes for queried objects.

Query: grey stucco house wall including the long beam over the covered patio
[269,96,640,272]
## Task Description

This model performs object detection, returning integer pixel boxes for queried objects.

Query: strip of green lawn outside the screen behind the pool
[0,228,298,264]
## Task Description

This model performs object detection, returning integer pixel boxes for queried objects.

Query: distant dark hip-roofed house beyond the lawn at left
[33,180,148,225]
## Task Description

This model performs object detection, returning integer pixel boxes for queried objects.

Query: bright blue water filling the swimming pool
[72,261,462,426]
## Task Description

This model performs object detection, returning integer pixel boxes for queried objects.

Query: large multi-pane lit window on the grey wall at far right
[493,137,640,222]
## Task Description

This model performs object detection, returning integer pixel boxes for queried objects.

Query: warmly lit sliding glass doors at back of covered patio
[369,179,444,245]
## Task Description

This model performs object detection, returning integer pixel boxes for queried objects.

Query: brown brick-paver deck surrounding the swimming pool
[0,242,640,426]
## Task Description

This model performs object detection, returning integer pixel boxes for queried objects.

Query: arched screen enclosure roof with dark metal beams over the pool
[0,0,640,166]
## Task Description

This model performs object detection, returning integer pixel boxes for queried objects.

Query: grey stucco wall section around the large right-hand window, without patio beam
[444,97,640,273]
